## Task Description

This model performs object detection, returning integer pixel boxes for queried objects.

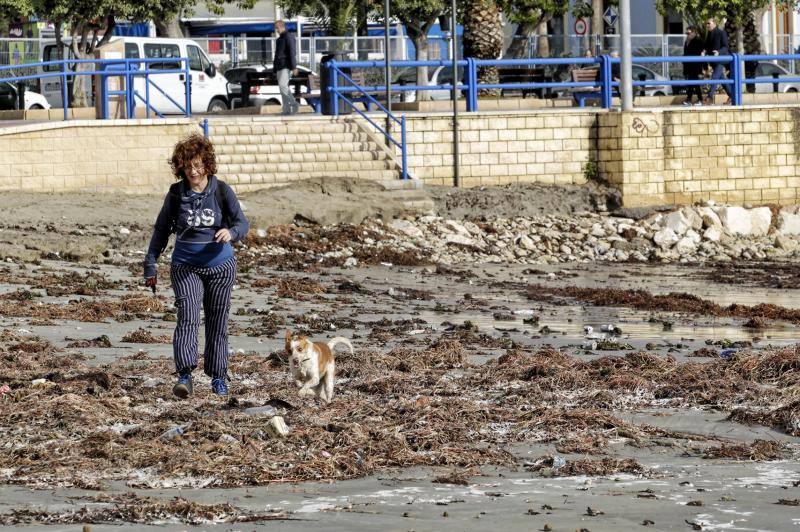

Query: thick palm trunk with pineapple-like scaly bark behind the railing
[463,0,503,95]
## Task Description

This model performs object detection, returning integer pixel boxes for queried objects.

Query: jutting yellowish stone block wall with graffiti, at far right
[598,106,800,206]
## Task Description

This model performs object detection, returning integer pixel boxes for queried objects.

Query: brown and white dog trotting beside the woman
[286,330,353,403]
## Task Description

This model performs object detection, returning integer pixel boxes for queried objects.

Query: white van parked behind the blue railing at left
[41,37,230,114]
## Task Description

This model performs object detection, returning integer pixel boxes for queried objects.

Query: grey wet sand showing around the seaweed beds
[0,260,800,532]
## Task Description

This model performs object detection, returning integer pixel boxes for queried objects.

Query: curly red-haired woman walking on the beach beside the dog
[144,134,249,399]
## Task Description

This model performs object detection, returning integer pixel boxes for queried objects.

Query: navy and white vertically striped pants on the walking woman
[170,258,236,378]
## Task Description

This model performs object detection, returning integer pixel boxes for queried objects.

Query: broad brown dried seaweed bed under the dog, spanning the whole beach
[0,333,800,488]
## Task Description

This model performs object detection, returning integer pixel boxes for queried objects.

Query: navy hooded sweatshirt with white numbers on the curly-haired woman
[144,176,250,278]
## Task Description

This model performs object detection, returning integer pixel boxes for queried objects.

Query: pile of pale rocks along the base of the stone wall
[252,204,800,266]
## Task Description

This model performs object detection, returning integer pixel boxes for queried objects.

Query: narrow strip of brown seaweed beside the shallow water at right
[527,285,800,324]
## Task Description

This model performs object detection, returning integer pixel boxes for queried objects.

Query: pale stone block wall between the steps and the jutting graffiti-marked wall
[406,109,604,187]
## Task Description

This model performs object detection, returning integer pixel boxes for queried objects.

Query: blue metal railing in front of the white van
[0,57,192,120]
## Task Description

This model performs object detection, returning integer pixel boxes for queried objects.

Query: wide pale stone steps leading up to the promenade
[209,118,406,187]
